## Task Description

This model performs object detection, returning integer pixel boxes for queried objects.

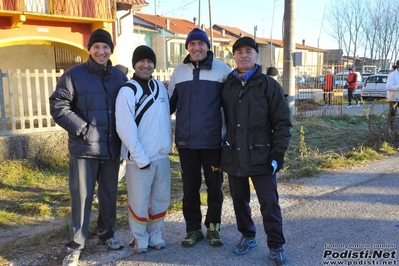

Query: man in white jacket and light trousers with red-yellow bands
[116,45,172,254]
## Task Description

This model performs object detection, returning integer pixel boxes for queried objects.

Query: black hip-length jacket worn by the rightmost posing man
[221,67,291,176]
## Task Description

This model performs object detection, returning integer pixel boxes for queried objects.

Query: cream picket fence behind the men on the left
[0,69,172,136]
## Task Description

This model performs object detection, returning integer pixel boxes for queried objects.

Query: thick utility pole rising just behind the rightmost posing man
[283,0,296,115]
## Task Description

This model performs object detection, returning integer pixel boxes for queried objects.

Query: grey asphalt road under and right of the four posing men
[74,153,399,266]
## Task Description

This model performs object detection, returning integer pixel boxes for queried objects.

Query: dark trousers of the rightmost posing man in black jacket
[229,174,285,249]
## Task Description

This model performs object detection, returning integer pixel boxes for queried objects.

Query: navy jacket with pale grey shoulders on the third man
[168,51,231,149]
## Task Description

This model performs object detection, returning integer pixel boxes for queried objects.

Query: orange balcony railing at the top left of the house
[0,0,116,20]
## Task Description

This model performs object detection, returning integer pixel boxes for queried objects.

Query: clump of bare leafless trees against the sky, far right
[327,0,399,68]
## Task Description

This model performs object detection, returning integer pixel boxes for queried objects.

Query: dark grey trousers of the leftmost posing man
[66,156,119,254]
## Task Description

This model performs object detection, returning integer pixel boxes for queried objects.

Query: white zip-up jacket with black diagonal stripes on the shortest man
[115,79,172,168]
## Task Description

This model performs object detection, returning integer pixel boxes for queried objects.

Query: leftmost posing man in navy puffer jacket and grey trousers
[50,29,127,266]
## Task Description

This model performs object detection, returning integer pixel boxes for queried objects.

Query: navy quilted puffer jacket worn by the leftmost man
[50,57,127,160]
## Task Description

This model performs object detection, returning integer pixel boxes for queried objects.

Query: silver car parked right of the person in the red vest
[360,74,388,100]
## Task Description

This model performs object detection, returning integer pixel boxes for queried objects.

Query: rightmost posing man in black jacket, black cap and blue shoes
[221,37,292,266]
